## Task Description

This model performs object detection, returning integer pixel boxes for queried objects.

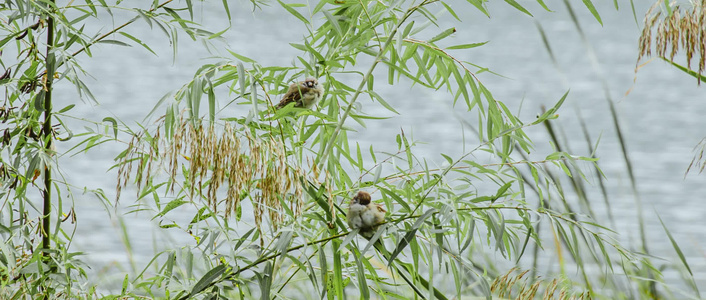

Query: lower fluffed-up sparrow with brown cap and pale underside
[346,191,387,239]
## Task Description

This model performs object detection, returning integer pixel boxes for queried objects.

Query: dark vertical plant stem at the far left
[41,0,56,262]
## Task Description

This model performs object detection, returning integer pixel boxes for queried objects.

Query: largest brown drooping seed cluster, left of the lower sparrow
[117,116,304,229]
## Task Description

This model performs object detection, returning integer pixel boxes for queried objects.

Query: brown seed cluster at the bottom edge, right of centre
[490,268,592,299]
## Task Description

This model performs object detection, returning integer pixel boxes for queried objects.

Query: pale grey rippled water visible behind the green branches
[55,1,706,290]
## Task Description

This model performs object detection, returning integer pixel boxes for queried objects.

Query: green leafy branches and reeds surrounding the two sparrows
[0,0,703,299]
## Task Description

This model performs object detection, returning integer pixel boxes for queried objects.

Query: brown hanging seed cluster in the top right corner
[637,0,706,84]
